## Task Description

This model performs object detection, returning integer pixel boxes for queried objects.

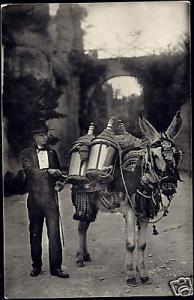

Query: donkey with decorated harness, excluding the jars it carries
[77,112,182,286]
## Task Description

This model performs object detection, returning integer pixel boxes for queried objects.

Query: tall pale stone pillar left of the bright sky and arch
[46,4,83,165]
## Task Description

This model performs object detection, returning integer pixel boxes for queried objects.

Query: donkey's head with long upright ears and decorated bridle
[139,112,182,197]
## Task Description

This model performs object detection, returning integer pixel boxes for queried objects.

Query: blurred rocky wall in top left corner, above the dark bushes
[3,4,54,84]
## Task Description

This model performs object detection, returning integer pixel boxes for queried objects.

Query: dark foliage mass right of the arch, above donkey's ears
[144,54,189,130]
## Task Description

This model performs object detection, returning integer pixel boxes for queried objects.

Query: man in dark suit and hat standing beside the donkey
[22,120,69,278]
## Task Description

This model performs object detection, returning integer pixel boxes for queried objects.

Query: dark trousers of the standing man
[27,196,62,271]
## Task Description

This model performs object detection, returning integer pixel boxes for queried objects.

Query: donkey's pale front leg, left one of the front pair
[124,208,137,286]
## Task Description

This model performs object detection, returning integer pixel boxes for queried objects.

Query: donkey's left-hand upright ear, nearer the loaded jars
[139,115,160,143]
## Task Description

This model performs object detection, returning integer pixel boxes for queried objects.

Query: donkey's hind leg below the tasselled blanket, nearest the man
[77,221,91,267]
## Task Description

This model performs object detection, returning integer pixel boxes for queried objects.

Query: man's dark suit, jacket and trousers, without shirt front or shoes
[22,145,62,270]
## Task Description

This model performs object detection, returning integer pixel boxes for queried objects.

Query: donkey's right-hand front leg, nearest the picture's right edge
[137,219,151,284]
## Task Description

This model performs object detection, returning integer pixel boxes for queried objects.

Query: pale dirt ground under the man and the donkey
[4,174,193,299]
